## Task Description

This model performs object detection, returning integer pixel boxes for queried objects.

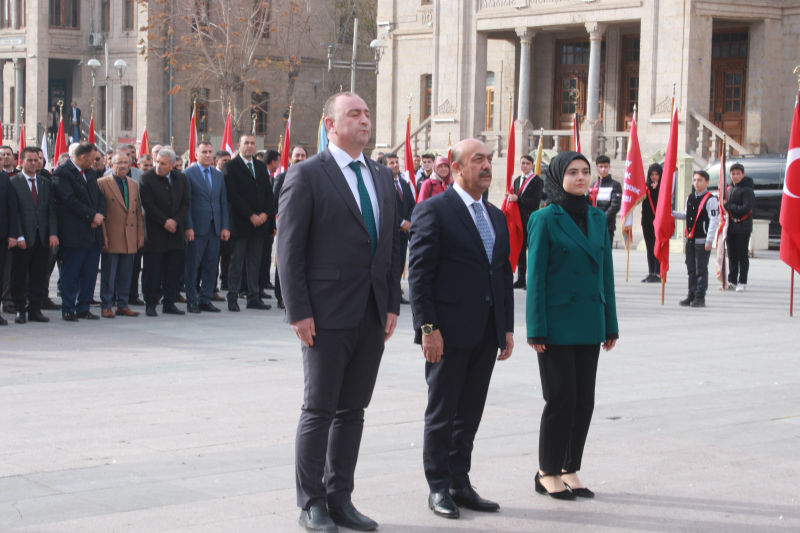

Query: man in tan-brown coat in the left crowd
[97,152,144,318]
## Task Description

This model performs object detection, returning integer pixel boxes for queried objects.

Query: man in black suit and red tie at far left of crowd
[11,147,58,324]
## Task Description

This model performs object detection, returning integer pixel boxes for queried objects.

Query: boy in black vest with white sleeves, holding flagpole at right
[672,170,719,307]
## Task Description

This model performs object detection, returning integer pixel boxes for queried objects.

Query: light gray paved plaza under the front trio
[0,250,800,533]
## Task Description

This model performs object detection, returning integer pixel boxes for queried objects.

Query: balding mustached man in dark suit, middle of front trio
[408,139,514,518]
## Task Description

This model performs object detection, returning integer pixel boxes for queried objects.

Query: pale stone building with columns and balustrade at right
[376,0,800,172]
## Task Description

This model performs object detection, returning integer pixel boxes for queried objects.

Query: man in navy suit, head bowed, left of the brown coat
[53,142,106,322]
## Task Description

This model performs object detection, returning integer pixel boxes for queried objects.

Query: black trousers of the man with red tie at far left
[11,236,50,312]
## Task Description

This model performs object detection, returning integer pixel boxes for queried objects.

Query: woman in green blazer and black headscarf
[525,152,619,500]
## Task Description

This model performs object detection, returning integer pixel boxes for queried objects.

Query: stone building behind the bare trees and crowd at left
[0,0,376,154]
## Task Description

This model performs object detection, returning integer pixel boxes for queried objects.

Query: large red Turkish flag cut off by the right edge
[780,91,800,270]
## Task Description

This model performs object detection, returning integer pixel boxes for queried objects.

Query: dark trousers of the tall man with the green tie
[295,291,385,509]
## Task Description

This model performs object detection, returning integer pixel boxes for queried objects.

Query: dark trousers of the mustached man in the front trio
[422,312,498,492]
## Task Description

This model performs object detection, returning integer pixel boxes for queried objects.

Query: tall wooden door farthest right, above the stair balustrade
[709,28,749,155]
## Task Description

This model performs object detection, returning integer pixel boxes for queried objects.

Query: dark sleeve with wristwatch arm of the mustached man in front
[408,202,440,331]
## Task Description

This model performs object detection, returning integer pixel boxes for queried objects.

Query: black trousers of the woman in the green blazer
[538,344,600,474]
